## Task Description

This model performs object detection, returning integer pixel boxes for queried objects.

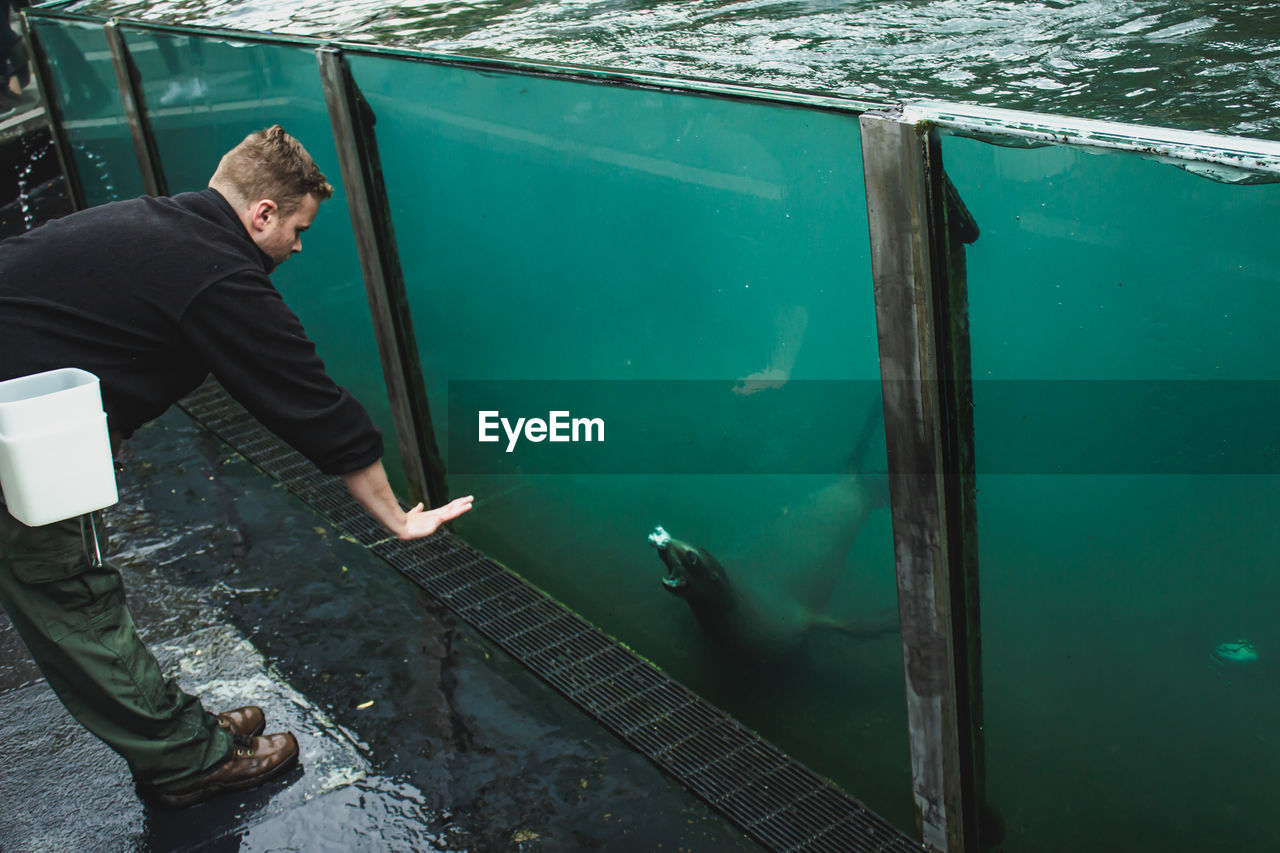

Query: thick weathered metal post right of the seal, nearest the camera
[859,113,984,853]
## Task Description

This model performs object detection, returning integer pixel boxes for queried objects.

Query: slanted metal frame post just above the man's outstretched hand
[316,46,448,506]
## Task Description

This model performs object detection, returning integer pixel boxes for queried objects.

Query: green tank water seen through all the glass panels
[24,9,1280,852]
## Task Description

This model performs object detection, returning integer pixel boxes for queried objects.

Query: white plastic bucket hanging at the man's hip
[0,368,119,528]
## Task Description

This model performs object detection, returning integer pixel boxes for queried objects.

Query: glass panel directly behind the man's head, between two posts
[124,29,404,494]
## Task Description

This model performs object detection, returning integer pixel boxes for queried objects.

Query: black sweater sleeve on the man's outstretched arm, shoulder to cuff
[180,273,383,474]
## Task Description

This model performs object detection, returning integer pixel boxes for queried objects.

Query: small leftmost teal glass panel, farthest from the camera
[31,17,142,207]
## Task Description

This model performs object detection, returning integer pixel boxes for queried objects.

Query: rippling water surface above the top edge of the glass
[64,0,1280,140]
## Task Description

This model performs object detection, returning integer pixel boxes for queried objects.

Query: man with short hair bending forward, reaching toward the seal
[0,126,471,808]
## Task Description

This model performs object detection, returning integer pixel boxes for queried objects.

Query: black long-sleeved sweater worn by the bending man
[0,190,383,474]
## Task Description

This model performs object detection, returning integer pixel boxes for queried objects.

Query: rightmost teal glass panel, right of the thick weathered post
[943,138,1280,853]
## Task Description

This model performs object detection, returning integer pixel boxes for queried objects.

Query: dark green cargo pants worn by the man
[0,503,232,790]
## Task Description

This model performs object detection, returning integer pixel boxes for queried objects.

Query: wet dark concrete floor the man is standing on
[0,411,758,853]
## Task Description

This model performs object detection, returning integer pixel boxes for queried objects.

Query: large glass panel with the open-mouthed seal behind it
[351,56,914,830]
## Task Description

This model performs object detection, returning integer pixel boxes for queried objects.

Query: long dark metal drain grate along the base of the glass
[180,382,927,853]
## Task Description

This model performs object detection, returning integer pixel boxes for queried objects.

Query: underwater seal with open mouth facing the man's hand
[649,399,897,661]
